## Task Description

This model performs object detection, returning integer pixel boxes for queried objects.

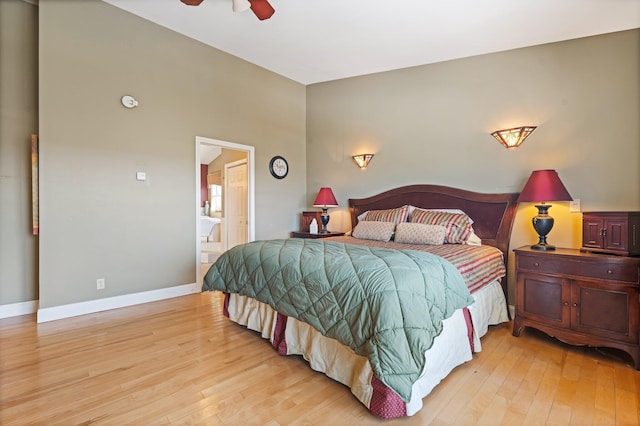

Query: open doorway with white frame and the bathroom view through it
[196,136,255,284]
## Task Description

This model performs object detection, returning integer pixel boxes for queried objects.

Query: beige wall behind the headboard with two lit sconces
[306,30,640,302]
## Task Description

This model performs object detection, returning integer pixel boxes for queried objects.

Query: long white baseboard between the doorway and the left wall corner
[38,283,200,323]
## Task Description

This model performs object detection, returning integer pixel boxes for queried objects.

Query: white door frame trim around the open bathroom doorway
[195,136,256,283]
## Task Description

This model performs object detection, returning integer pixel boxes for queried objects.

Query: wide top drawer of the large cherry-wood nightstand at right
[517,256,640,283]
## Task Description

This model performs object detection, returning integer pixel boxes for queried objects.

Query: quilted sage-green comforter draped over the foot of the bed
[202,238,473,402]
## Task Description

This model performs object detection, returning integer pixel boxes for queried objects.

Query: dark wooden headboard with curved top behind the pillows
[349,185,520,294]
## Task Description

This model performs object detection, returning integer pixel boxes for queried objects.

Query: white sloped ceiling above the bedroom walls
[103,0,640,85]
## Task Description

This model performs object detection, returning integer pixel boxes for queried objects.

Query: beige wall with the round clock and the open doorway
[34,0,306,308]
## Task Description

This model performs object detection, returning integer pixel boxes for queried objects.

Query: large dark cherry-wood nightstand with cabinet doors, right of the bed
[513,246,640,369]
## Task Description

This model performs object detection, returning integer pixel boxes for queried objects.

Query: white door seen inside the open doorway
[224,160,249,250]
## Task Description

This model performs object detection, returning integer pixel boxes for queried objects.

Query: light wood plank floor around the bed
[0,293,640,426]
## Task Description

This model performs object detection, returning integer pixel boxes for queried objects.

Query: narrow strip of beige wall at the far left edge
[0,0,38,305]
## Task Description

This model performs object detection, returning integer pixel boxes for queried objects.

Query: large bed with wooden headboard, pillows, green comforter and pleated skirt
[203,185,518,418]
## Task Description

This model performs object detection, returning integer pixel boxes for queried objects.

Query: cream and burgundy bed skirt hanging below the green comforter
[224,281,509,418]
